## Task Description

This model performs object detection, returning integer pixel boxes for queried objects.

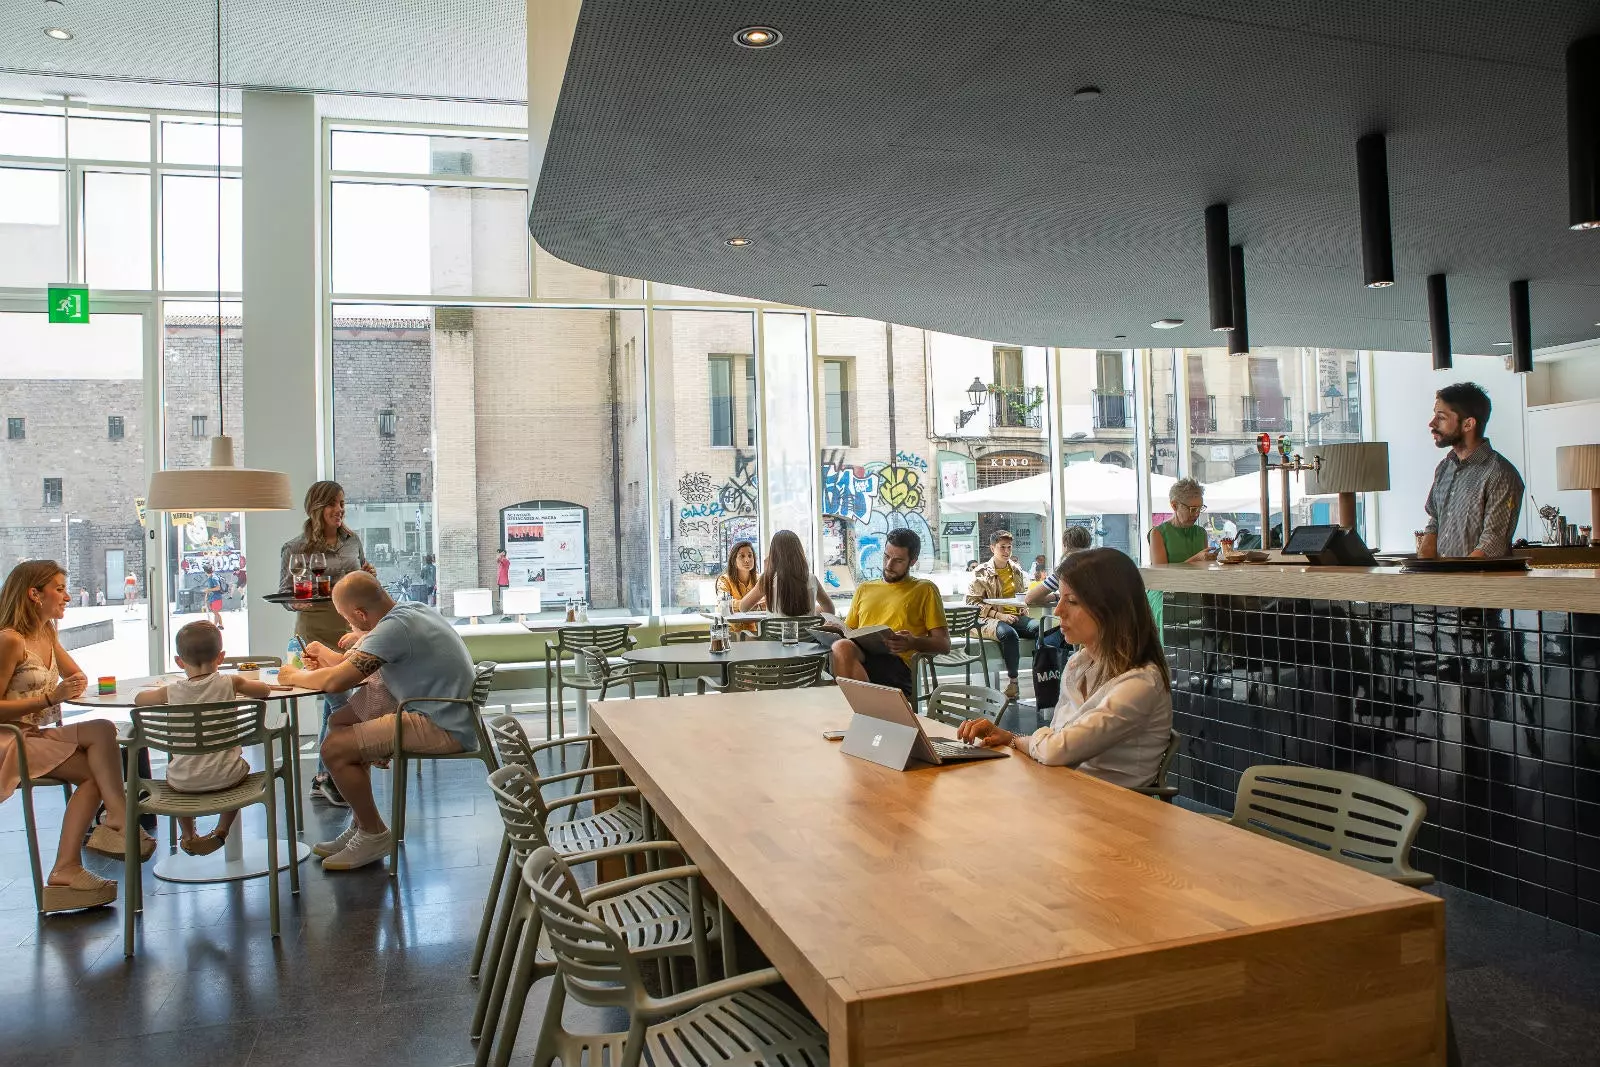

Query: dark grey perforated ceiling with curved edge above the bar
[531,0,1600,354]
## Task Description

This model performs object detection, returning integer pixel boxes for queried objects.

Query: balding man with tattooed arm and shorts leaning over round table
[278,571,478,870]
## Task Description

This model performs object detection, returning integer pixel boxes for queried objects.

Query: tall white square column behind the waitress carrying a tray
[242,91,325,656]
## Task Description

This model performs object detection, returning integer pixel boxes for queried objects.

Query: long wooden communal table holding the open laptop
[594,688,1445,1067]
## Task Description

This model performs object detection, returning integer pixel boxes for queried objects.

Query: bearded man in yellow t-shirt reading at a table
[832,530,950,694]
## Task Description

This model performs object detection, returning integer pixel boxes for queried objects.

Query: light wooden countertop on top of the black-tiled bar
[1139,563,1600,614]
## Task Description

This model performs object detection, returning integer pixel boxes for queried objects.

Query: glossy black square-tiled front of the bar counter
[1163,593,1600,933]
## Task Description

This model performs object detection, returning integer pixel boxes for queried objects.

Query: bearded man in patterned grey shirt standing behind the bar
[1418,382,1523,560]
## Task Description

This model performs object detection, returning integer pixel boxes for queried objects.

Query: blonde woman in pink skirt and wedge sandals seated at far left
[0,560,155,912]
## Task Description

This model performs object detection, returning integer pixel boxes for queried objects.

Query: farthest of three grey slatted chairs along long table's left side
[467,715,651,977]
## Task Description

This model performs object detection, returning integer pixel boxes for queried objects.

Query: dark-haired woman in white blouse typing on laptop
[958,549,1173,789]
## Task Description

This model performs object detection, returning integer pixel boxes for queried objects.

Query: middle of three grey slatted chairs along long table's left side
[472,766,720,1067]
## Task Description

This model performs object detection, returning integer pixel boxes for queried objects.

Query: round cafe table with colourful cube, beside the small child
[64,670,322,885]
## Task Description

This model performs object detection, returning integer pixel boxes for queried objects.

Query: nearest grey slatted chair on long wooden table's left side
[522,848,829,1067]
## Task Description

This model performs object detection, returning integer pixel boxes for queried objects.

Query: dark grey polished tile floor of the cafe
[0,715,1600,1067]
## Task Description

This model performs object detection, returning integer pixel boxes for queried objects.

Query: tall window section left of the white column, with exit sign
[0,101,250,675]
